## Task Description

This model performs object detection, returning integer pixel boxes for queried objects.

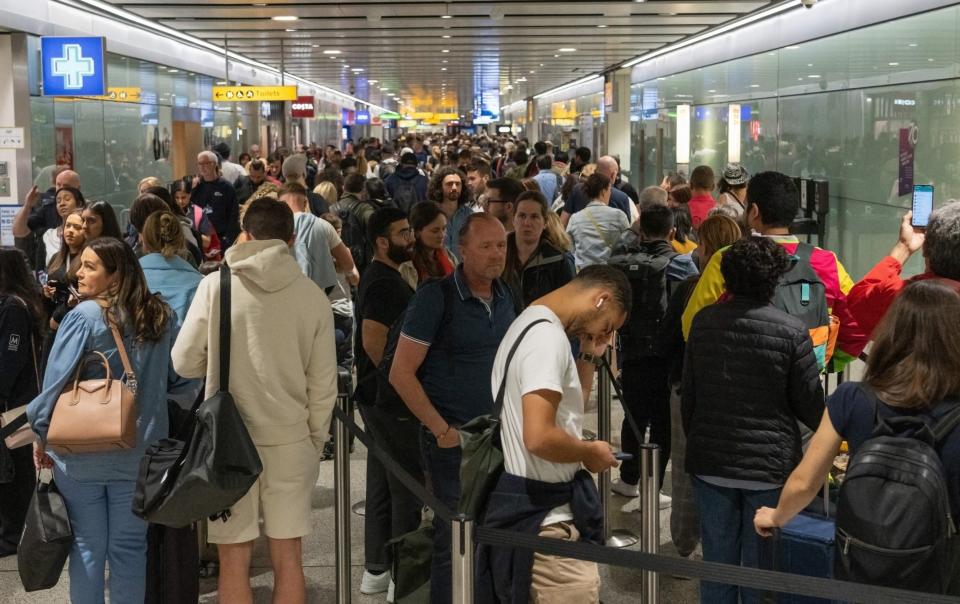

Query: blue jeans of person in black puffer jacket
[693,476,780,604]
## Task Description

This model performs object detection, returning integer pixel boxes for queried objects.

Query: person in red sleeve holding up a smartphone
[847,202,960,334]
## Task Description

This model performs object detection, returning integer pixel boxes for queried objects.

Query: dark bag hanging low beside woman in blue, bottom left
[17,477,73,591]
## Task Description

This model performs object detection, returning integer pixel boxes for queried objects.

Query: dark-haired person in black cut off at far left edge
[0,247,46,558]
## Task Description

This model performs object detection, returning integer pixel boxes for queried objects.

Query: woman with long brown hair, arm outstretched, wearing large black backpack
[753,279,960,595]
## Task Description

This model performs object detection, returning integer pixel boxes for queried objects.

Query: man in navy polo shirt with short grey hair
[390,214,515,604]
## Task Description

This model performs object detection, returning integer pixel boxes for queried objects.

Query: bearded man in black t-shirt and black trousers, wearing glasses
[355,207,423,601]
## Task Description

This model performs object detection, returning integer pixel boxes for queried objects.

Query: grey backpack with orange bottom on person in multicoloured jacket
[773,243,840,372]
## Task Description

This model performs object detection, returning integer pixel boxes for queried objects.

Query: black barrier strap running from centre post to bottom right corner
[475,526,960,604]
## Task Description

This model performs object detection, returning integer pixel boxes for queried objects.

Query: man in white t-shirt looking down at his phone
[478,265,631,602]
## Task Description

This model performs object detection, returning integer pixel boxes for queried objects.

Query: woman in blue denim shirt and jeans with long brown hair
[27,238,187,604]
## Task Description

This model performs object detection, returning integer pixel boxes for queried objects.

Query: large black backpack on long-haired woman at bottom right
[834,397,960,593]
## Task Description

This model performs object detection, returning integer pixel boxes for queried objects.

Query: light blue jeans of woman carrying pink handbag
[54,470,147,604]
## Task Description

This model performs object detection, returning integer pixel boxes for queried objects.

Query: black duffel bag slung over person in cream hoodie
[133,265,263,528]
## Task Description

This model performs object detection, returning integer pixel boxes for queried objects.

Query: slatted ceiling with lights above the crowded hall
[95,0,773,113]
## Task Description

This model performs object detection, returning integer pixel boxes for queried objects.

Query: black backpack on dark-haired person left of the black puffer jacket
[609,251,680,358]
